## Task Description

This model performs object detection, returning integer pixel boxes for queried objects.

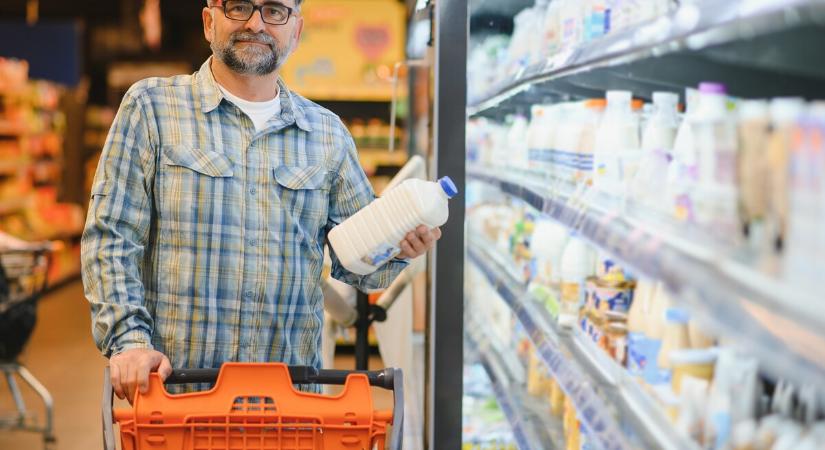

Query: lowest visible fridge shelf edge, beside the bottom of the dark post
[467,312,564,450]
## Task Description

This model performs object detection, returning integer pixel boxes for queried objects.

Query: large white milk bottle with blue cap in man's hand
[329,177,458,275]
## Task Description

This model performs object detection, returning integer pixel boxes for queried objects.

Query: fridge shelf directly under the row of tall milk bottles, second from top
[467,168,825,394]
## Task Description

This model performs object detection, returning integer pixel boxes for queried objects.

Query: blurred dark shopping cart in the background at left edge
[0,239,55,446]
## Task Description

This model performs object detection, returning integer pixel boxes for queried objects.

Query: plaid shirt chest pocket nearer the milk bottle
[272,166,329,243]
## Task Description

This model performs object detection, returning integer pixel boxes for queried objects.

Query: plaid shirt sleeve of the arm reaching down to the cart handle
[81,89,155,357]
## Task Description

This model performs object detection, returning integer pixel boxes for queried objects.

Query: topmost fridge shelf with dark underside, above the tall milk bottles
[468,0,825,116]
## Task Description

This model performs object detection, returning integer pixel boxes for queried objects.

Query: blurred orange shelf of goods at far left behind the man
[0,58,83,283]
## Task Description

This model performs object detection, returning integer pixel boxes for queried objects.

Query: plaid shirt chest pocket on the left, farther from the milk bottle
[157,145,240,238]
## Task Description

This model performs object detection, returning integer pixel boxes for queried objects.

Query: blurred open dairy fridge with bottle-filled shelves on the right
[467,0,825,449]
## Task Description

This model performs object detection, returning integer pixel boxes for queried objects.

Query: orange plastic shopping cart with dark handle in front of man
[102,363,404,450]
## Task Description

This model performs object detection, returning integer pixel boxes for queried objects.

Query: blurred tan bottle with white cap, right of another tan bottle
[768,97,805,248]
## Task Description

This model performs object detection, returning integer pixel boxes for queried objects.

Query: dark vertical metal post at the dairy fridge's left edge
[425,0,468,449]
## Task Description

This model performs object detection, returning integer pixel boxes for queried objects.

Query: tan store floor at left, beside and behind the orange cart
[0,281,404,450]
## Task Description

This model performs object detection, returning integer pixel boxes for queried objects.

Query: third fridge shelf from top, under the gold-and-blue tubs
[468,243,698,450]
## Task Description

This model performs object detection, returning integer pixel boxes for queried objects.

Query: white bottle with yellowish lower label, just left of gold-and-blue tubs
[559,233,596,327]
